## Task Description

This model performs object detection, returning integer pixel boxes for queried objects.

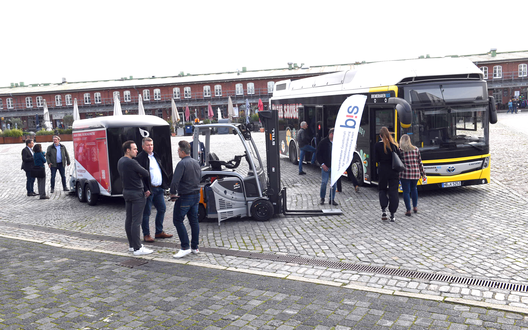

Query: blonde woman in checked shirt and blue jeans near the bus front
[400,134,427,217]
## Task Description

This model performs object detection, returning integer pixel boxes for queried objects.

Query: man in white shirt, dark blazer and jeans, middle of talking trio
[136,137,172,243]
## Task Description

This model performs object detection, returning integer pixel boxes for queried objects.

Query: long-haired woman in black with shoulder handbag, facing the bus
[374,126,400,222]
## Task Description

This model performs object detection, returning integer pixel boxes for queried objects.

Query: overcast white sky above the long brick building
[0,0,528,87]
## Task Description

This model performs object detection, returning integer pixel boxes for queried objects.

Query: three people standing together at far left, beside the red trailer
[21,135,70,199]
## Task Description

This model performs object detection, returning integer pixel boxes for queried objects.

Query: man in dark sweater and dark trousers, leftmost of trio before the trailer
[117,140,154,256]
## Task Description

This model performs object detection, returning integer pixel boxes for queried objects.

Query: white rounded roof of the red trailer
[72,115,169,131]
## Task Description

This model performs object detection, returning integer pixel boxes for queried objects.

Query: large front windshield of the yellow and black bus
[403,83,489,150]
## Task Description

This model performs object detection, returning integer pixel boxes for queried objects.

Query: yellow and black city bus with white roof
[270,58,497,188]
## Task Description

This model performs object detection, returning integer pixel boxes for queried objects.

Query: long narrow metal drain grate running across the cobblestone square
[4,221,528,292]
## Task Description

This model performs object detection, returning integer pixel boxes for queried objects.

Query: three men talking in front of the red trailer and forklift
[117,137,201,258]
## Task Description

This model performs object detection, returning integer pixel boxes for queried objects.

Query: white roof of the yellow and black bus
[272,58,483,100]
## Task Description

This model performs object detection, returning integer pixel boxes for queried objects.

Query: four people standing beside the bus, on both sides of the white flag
[297,121,427,222]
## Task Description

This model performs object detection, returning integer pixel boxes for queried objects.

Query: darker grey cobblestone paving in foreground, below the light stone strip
[0,238,528,330]
